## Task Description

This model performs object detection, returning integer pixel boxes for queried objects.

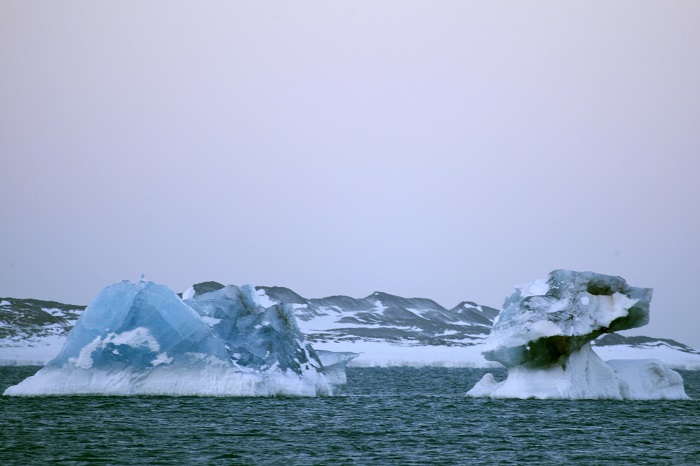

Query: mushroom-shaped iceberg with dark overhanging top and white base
[467,270,688,400]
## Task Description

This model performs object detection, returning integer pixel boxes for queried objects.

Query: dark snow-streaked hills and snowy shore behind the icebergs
[0,282,700,369]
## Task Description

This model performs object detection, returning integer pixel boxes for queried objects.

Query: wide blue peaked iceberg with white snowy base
[4,280,352,396]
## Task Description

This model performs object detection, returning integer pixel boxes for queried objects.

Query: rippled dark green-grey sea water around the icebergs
[0,367,700,465]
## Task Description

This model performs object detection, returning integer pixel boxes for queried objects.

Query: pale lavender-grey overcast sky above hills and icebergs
[0,0,700,348]
